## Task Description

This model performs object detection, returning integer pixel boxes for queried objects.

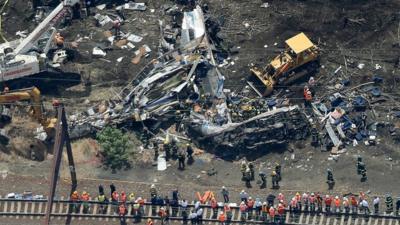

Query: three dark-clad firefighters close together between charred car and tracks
[240,160,282,189]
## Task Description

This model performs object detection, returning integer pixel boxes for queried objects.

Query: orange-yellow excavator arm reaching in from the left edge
[0,87,57,136]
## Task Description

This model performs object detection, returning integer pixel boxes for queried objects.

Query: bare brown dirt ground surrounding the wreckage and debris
[0,0,400,208]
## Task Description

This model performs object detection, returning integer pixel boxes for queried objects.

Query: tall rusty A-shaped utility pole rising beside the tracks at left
[45,104,77,225]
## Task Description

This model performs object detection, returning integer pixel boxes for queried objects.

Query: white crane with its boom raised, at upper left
[0,0,80,82]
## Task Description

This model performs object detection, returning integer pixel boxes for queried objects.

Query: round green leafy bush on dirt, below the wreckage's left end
[97,127,132,172]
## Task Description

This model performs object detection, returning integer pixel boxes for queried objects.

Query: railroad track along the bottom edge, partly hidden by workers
[0,196,400,225]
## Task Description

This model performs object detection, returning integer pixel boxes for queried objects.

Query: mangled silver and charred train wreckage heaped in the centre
[70,6,309,152]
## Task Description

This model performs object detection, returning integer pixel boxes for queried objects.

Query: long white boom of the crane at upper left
[14,0,79,54]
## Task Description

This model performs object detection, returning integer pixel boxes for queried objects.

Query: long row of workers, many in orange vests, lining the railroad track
[70,184,400,225]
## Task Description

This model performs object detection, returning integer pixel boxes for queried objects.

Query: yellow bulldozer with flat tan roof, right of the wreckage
[250,33,319,96]
